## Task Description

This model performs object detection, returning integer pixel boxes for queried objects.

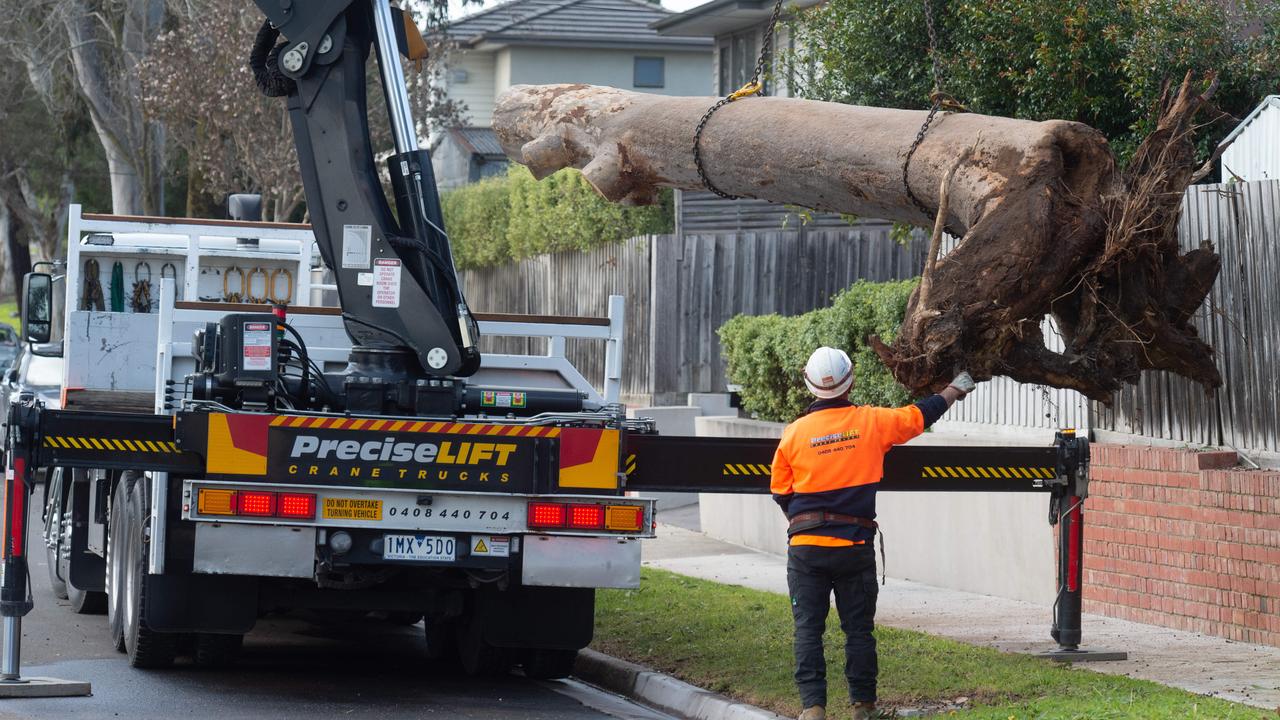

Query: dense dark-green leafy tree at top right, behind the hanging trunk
[782,0,1280,164]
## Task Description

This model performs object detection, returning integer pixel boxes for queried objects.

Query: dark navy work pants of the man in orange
[787,543,879,707]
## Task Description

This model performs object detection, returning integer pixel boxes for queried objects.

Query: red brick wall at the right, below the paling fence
[1084,445,1280,646]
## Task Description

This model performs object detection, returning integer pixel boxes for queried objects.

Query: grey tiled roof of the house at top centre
[448,0,710,50]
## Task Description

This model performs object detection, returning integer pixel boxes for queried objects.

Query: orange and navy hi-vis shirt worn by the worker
[771,400,924,547]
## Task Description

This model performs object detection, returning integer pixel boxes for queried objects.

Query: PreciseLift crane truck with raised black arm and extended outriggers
[0,0,1088,679]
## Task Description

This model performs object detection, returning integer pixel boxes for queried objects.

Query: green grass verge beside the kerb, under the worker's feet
[593,568,1275,720]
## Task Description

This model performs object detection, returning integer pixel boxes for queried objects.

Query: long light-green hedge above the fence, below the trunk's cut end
[440,163,675,268]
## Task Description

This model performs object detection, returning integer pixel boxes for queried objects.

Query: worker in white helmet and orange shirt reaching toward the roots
[771,347,974,720]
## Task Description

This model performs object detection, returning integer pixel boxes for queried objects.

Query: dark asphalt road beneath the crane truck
[0,481,669,720]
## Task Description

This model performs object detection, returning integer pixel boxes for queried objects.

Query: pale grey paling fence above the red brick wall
[1093,181,1280,452]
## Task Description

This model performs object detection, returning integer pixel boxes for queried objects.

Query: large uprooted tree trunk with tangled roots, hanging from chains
[493,78,1221,401]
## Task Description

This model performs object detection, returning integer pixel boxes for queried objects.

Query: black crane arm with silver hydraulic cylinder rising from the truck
[251,0,480,377]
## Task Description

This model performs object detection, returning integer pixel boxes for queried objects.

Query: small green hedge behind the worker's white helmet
[719,279,919,421]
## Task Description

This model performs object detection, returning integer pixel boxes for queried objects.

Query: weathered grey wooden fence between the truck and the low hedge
[462,223,924,404]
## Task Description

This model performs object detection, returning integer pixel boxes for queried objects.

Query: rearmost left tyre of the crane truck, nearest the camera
[120,483,178,669]
